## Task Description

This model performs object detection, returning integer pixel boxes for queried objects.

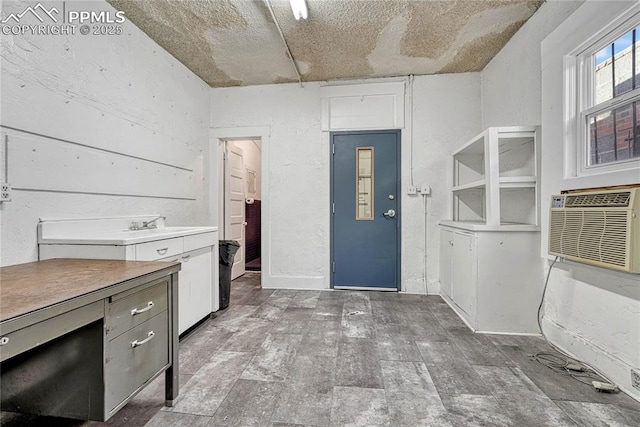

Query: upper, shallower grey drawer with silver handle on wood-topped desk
[107,280,169,340]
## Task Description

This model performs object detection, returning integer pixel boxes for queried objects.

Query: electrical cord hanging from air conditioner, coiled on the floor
[529,256,618,391]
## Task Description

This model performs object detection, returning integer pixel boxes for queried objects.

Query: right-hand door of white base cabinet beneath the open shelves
[451,232,477,323]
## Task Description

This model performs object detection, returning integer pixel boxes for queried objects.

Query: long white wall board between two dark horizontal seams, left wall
[3,130,196,200]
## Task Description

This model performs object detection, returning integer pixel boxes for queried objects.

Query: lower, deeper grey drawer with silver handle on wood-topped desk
[105,311,168,411]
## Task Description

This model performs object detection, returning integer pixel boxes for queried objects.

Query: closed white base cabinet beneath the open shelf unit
[440,226,544,334]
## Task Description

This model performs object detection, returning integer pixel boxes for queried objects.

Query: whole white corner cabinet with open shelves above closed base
[440,126,543,333]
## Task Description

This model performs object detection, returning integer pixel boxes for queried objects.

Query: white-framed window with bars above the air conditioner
[577,15,640,173]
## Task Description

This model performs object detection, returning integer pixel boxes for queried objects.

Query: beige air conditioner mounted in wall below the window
[549,188,640,273]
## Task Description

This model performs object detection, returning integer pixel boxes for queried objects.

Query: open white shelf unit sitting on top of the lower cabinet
[445,126,540,231]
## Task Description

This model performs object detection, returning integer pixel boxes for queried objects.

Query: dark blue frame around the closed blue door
[329,129,402,292]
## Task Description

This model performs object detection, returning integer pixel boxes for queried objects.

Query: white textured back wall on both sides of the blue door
[211,74,481,293]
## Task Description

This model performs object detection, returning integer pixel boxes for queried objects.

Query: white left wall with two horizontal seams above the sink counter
[0,1,209,265]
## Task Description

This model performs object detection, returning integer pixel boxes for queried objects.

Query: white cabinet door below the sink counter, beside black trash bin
[178,247,213,333]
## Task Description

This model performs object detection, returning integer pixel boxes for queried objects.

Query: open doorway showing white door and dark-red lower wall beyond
[218,138,262,280]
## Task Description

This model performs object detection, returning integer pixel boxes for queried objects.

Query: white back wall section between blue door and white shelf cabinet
[402,73,482,294]
